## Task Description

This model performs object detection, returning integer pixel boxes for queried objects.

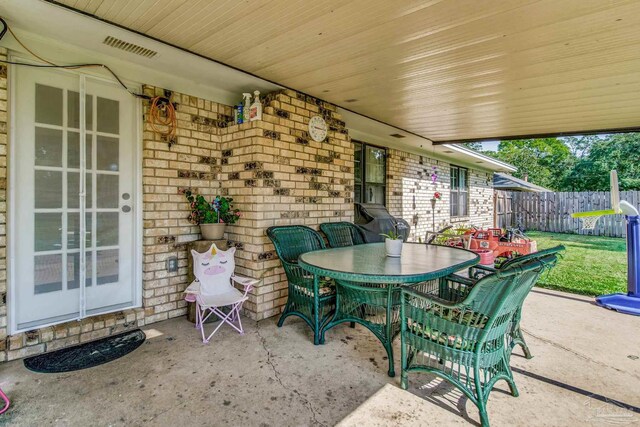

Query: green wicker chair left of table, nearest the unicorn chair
[267,225,336,345]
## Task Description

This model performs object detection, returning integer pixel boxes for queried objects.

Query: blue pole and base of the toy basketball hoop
[596,215,640,316]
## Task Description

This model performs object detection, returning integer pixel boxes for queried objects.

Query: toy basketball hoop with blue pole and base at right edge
[571,170,640,316]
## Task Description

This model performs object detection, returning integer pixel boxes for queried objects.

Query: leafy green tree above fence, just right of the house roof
[494,138,575,190]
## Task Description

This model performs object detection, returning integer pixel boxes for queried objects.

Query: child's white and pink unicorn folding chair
[185,243,259,344]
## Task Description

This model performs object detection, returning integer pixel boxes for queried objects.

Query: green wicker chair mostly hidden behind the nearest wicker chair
[444,245,565,359]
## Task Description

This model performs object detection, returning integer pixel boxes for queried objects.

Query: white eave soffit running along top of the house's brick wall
[0,0,515,171]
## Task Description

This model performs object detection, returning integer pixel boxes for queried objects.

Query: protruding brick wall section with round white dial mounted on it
[221,90,354,319]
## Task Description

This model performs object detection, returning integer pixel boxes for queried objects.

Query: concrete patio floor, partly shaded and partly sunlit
[0,289,640,427]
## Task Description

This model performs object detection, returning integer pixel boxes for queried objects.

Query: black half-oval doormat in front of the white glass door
[24,329,146,373]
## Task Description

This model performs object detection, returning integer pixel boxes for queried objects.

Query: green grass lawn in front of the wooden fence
[527,231,627,295]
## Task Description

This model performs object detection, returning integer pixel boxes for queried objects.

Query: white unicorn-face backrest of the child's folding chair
[191,243,236,297]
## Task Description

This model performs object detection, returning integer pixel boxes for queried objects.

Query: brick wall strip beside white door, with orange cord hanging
[142,86,232,323]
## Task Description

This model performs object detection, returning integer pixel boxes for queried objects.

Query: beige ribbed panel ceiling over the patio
[38,0,640,141]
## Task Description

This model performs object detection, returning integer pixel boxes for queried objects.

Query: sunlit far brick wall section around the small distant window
[387,149,493,241]
